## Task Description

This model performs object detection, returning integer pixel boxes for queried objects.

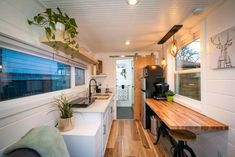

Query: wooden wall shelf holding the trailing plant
[40,37,98,64]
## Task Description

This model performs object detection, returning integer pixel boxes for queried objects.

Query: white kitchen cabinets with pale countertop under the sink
[62,96,114,157]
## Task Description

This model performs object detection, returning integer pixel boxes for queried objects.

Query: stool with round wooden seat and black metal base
[169,130,197,157]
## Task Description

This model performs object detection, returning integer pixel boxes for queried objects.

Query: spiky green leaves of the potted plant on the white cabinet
[56,95,73,119]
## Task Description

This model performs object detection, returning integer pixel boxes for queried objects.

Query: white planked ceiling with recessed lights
[40,0,219,52]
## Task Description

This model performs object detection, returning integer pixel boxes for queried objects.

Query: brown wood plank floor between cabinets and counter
[105,119,173,157]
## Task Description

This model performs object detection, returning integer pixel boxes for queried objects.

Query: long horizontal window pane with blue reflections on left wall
[0,48,71,101]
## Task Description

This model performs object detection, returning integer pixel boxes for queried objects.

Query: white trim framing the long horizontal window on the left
[0,32,89,103]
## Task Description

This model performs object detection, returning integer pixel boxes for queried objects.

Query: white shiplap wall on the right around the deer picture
[167,0,235,157]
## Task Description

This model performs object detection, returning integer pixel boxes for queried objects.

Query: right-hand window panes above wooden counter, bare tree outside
[175,39,201,101]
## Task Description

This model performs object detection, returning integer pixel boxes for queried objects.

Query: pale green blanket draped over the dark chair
[3,126,69,157]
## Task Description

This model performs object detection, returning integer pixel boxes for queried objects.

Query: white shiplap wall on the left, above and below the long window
[0,0,90,156]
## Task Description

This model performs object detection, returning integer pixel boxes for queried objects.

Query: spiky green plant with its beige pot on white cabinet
[56,95,74,132]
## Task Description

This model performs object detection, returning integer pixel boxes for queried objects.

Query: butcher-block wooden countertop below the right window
[145,98,228,133]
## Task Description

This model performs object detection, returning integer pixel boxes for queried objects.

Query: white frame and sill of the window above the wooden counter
[173,37,203,111]
